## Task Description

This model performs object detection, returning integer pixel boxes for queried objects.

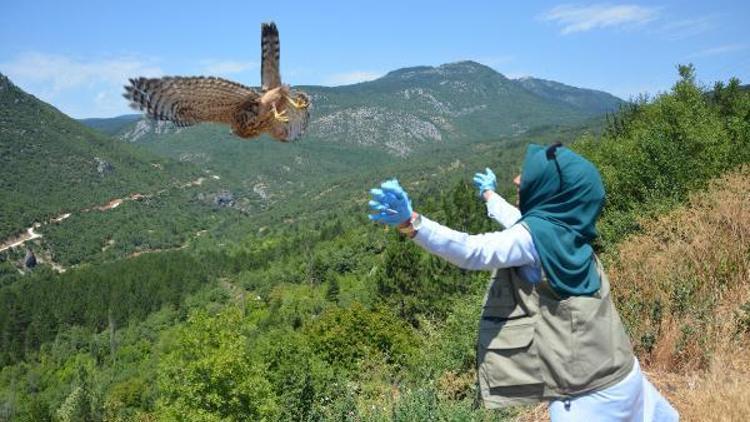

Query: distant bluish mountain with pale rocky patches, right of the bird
[89,61,624,154]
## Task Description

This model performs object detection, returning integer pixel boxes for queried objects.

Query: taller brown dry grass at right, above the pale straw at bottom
[607,169,750,371]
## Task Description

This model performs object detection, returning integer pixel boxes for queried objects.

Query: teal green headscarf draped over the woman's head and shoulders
[519,144,604,296]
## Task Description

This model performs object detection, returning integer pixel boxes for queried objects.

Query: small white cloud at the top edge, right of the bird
[540,4,659,34]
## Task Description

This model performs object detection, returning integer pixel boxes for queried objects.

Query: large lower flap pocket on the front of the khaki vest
[477,318,543,387]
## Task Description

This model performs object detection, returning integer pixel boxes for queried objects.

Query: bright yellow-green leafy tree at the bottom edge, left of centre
[157,307,279,421]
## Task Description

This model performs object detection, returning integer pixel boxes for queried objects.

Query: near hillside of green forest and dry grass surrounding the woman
[0,67,750,421]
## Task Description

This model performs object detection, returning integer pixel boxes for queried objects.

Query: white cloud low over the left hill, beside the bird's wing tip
[0,52,164,118]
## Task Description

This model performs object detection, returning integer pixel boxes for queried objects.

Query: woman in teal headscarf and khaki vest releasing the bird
[370,144,679,421]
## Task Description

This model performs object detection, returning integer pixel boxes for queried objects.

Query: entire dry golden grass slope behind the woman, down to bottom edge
[608,168,750,421]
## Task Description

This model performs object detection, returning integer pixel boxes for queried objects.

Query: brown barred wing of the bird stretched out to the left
[123,76,260,126]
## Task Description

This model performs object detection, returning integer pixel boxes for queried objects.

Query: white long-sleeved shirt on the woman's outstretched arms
[414,194,541,283]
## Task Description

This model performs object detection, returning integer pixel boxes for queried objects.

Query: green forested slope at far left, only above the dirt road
[0,75,199,239]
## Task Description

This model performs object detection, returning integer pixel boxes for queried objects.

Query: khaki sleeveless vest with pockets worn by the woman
[477,252,635,408]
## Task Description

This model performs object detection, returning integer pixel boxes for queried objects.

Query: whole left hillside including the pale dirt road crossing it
[0,76,270,270]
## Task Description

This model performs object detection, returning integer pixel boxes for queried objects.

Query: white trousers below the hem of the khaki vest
[549,359,680,422]
